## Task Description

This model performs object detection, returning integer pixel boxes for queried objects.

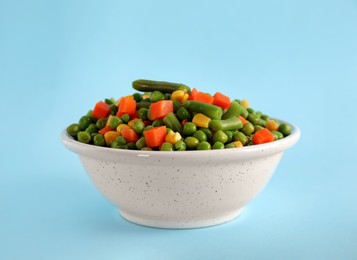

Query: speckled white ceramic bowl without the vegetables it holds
[61,123,300,228]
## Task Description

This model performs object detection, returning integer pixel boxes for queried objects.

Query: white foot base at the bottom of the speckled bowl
[119,208,243,229]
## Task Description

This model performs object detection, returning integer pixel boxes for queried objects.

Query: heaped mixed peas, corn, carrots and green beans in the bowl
[67,80,291,151]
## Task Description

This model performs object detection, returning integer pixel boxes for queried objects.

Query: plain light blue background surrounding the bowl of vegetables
[0,0,357,260]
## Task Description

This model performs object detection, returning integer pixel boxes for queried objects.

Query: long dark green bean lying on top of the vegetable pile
[133,79,191,93]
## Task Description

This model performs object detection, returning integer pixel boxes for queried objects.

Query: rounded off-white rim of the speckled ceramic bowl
[61,119,301,160]
